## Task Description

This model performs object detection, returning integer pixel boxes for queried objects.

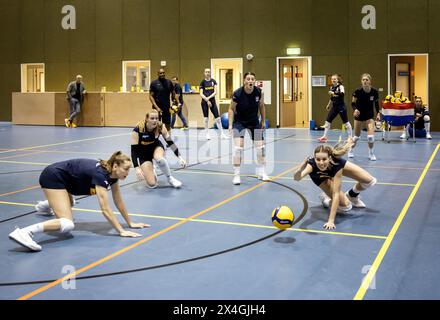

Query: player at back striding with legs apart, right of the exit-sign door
[318,74,352,142]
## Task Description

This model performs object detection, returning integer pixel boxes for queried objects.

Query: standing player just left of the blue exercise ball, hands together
[200,69,228,140]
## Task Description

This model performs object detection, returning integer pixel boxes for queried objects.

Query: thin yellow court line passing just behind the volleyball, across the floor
[0,201,386,239]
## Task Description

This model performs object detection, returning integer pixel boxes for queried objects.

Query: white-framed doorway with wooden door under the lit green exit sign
[277,57,311,128]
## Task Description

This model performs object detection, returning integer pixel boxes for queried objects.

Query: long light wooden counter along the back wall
[12,92,220,128]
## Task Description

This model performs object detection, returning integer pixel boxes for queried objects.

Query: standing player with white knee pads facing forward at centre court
[229,72,270,185]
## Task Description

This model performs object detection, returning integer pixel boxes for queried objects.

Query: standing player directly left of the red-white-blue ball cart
[348,73,380,161]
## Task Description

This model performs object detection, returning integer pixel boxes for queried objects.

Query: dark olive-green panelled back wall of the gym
[0,0,440,131]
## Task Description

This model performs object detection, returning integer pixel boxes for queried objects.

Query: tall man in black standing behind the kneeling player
[149,68,180,132]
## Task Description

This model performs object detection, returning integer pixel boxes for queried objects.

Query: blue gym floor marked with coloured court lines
[0,123,440,300]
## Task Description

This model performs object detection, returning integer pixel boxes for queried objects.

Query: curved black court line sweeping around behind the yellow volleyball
[0,170,309,287]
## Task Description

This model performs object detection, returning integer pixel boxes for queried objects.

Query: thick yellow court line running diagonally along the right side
[354,144,440,300]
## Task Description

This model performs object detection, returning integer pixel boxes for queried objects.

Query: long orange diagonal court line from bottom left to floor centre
[17,168,294,300]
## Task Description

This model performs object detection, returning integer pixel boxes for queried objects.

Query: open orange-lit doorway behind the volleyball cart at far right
[388,54,429,105]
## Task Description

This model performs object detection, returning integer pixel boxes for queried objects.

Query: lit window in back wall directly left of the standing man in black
[121,60,151,92]
